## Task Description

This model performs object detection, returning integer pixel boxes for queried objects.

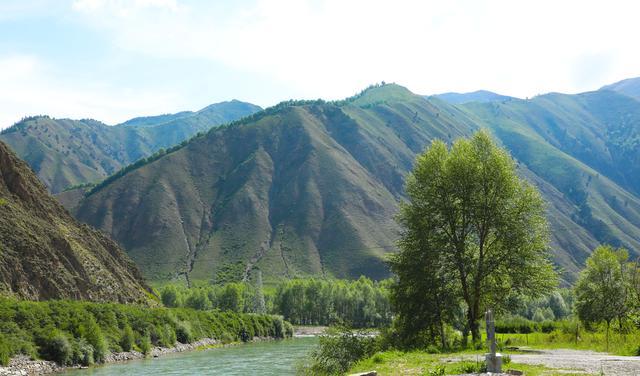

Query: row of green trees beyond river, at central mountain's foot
[160,277,392,328]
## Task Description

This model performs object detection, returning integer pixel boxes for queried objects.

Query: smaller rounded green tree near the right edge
[575,246,631,351]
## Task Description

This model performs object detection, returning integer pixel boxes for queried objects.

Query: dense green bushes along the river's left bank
[0,298,293,374]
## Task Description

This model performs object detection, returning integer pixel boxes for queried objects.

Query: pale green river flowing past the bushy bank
[62,337,318,376]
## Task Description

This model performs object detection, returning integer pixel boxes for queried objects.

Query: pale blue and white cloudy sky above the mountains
[0,0,640,128]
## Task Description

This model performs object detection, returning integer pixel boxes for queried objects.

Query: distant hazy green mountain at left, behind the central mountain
[0,101,260,193]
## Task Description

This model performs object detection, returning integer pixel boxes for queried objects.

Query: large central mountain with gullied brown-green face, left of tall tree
[77,85,480,280]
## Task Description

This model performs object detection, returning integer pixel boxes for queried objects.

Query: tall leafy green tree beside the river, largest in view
[392,131,557,341]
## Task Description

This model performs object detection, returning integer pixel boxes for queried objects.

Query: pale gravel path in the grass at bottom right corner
[511,350,640,376]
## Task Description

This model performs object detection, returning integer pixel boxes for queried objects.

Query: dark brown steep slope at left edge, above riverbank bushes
[0,142,149,303]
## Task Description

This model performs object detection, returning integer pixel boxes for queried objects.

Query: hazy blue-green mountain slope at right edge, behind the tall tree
[463,91,640,268]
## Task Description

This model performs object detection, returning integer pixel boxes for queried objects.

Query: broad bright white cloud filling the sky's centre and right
[65,0,640,97]
